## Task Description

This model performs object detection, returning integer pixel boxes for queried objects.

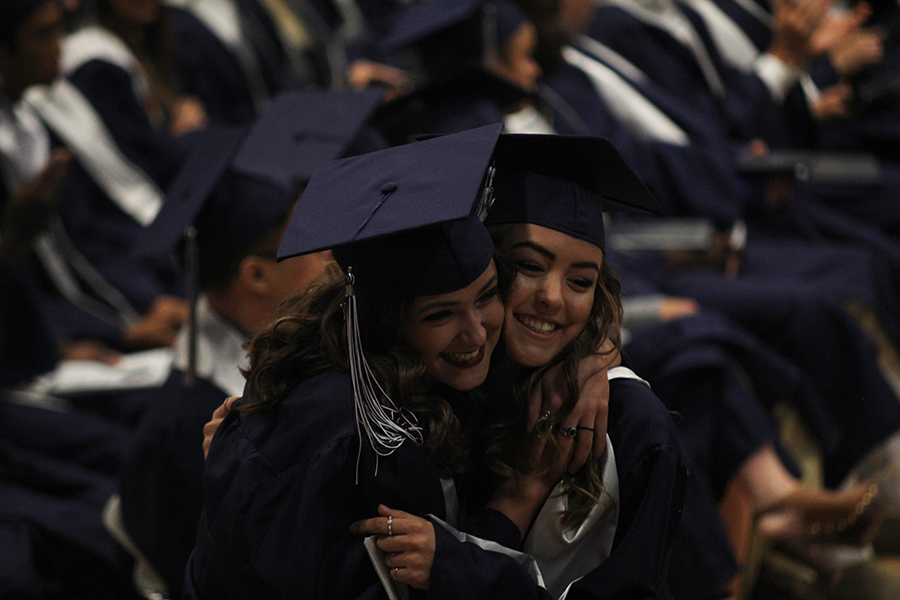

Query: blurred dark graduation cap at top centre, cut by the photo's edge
[380,0,526,79]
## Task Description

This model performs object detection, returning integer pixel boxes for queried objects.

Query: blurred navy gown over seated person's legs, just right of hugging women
[625,311,809,599]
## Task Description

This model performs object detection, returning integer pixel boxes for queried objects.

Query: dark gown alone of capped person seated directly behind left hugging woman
[119,369,228,597]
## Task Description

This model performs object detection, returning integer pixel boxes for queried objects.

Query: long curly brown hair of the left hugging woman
[239,263,492,476]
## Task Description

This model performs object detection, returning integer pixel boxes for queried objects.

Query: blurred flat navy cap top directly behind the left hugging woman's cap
[234,90,383,188]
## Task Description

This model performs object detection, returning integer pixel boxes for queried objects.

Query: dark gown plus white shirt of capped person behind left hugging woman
[119,299,247,597]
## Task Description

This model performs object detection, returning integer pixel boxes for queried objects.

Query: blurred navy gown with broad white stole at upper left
[27,27,186,313]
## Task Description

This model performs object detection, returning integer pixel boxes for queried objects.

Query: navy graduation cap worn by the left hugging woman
[278,125,501,296]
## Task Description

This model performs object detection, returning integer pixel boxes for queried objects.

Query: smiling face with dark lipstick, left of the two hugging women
[403,261,503,391]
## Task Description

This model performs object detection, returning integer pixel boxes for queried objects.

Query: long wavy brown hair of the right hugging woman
[485,225,622,531]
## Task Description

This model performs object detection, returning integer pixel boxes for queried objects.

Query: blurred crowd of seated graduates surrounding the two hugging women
[0,0,900,600]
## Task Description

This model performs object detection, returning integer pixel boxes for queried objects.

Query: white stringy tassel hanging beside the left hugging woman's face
[344,269,423,483]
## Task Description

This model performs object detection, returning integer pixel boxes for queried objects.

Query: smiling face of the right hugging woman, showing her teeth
[503,224,603,367]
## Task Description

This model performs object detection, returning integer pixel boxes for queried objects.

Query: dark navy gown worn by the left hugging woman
[185,372,560,599]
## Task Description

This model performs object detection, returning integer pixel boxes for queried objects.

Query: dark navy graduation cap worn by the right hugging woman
[485,134,662,248]
